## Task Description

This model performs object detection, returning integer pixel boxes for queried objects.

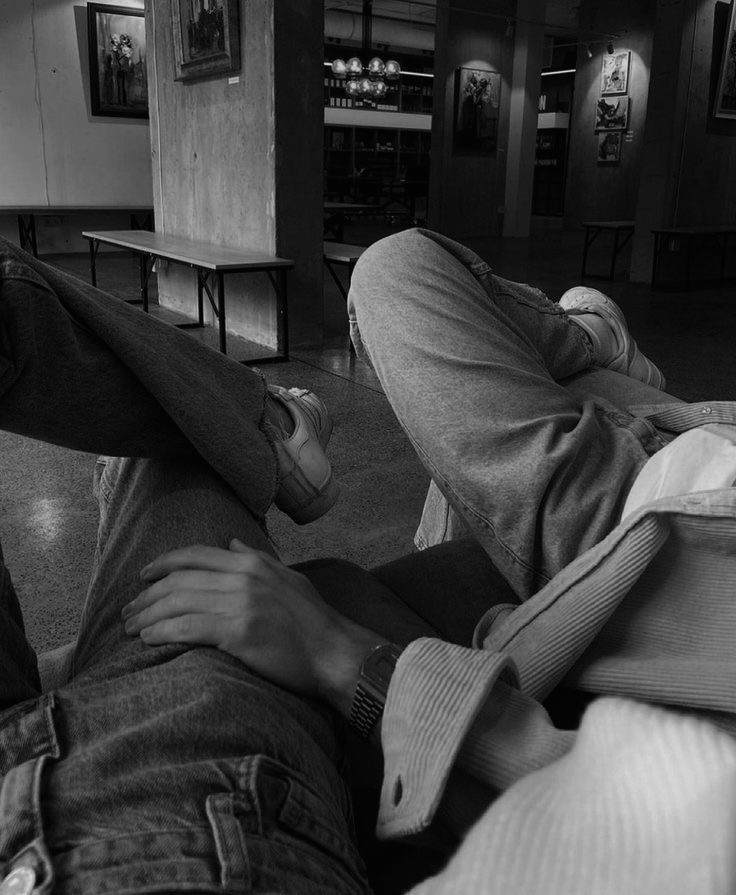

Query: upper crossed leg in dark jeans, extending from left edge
[0,234,278,516]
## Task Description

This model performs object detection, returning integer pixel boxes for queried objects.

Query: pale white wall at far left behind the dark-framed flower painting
[0,0,152,252]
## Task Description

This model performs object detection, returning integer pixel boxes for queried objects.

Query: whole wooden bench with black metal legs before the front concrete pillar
[82,230,294,364]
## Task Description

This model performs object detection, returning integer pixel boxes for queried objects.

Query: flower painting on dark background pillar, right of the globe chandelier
[453,68,501,155]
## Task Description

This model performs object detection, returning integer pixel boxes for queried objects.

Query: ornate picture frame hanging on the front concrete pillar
[171,0,240,81]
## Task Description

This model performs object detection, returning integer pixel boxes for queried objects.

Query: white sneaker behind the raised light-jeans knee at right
[560,286,665,389]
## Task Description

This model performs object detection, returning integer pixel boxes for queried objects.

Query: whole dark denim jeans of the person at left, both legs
[0,243,368,895]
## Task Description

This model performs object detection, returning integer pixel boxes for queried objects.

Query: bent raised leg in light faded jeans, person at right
[349,230,661,597]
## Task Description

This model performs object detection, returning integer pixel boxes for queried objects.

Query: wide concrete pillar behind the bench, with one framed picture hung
[146,0,323,347]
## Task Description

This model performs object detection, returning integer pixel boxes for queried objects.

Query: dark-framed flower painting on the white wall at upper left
[87,3,148,118]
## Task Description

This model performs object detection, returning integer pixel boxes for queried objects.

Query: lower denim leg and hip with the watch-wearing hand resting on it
[0,459,367,895]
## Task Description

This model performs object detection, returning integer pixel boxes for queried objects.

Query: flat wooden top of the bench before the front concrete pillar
[82,230,294,271]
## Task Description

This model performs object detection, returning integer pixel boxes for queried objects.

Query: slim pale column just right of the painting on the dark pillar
[501,0,544,236]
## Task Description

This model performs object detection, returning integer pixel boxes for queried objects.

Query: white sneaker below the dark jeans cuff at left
[268,385,340,525]
